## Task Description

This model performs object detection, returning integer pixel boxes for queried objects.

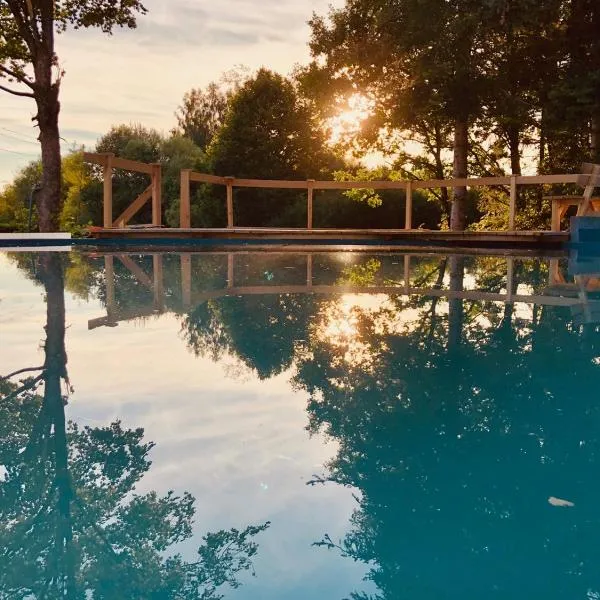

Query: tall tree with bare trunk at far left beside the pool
[0,0,146,231]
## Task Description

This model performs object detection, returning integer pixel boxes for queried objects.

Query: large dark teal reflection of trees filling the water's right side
[295,264,600,599]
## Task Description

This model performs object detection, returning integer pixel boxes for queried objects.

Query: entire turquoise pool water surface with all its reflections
[0,250,600,600]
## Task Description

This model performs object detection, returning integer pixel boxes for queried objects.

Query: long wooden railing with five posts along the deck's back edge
[180,170,582,231]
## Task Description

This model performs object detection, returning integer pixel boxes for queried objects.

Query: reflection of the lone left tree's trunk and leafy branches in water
[0,254,268,600]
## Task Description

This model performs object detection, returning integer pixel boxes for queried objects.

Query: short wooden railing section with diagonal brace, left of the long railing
[83,152,162,229]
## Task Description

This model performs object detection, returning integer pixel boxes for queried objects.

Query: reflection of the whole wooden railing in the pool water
[88,252,600,329]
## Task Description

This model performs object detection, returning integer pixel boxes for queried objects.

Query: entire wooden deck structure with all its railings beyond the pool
[84,152,600,245]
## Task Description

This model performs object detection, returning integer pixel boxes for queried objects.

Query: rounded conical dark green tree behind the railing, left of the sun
[208,69,334,226]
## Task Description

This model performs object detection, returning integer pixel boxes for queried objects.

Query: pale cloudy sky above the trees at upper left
[0,0,343,189]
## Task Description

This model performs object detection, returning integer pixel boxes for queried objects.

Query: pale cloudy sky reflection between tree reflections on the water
[0,253,366,599]
